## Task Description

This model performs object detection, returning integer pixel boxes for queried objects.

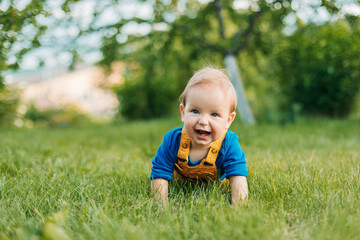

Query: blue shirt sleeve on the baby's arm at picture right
[223,134,248,178]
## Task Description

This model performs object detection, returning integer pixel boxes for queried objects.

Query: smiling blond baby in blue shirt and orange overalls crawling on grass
[150,68,248,206]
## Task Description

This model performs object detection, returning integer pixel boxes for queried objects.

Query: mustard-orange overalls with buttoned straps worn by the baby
[174,128,226,181]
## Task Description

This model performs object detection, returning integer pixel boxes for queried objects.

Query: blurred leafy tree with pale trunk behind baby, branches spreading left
[0,0,355,123]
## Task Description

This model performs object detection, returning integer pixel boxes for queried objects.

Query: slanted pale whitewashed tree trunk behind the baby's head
[224,54,255,124]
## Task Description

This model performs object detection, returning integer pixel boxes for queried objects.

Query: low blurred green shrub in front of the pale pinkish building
[24,104,89,127]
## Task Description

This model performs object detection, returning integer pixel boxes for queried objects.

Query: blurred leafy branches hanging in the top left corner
[0,0,79,89]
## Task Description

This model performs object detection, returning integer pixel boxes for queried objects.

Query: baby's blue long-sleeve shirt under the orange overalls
[150,127,248,181]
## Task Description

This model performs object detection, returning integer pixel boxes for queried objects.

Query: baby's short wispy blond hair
[180,67,237,112]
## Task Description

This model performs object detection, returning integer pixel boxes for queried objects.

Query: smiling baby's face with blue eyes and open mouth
[180,84,235,148]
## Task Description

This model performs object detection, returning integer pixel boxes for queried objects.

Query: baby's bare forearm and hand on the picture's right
[230,176,248,207]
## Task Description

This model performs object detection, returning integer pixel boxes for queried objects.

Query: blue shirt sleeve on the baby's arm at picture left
[150,131,179,181]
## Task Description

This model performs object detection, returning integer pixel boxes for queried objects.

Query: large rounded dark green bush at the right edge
[275,21,360,117]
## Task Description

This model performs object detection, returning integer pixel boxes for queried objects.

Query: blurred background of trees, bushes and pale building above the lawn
[0,0,360,128]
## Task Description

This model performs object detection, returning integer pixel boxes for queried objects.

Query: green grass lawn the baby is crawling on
[0,119,360,239]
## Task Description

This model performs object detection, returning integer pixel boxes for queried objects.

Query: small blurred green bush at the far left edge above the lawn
[0,88,19,125]
